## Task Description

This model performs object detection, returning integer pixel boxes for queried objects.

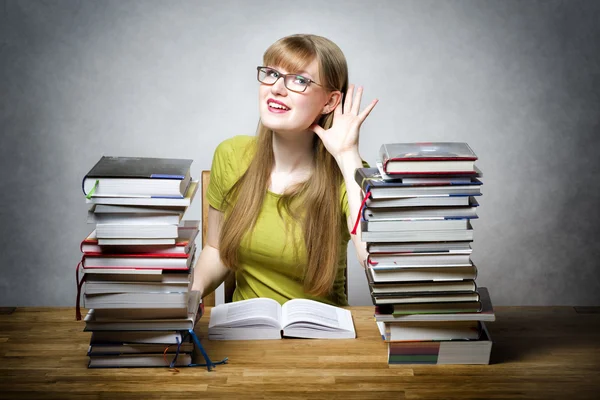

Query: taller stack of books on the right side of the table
[355,143,495,365]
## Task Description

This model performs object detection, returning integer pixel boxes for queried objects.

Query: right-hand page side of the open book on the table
[282,299,354,331]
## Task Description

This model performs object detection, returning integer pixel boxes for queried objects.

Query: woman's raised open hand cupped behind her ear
[309,85,378,159]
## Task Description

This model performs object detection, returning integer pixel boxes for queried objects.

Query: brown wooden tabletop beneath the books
[0,307,600,400]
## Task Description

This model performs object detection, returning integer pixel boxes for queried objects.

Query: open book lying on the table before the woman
[208,298,356,340]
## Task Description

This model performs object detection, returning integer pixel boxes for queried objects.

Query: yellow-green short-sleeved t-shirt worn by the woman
[206,136,350,305]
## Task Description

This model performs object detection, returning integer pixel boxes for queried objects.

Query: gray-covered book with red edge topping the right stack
[379,142,477,174]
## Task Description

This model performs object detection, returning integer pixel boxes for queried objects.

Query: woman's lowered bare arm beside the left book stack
[192,206,231,297]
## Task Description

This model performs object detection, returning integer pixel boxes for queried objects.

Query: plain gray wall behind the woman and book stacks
[0,0,600,306]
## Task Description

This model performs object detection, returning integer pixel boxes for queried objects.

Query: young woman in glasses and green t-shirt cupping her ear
[192,35,377,305]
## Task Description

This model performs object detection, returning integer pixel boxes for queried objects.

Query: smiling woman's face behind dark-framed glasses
[258,60,328,133]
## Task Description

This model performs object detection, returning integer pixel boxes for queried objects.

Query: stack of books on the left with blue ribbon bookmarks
[77,157,203,368]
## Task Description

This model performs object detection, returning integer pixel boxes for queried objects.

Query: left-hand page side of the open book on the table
[209,298,281,328]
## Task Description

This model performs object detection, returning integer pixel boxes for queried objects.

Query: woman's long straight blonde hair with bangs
[219,35,348,296]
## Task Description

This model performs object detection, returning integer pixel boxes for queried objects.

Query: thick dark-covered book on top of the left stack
[82,156,192,198]
